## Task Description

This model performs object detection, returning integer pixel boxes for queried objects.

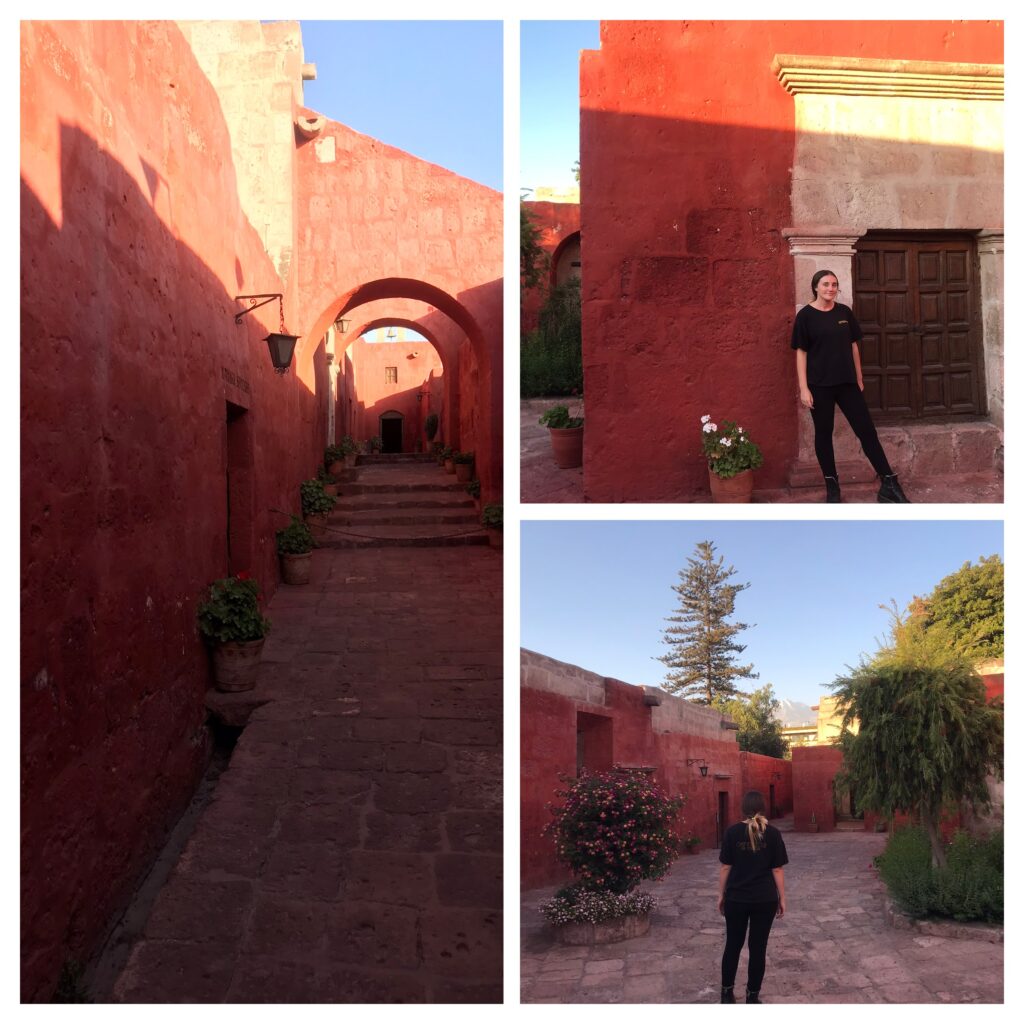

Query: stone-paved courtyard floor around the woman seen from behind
[522,833,1002,1004]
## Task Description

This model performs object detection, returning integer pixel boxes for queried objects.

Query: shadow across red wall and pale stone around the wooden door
[581,108,1001,502]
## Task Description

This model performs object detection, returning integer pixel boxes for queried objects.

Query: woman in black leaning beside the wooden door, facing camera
[791,270,909,504]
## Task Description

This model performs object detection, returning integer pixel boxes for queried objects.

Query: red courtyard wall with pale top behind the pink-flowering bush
[519,650,788,889]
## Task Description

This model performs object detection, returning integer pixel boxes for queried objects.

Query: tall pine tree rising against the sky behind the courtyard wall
[658,541,758,705]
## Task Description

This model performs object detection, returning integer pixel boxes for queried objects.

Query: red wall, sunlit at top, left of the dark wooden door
[580,18,1002,502]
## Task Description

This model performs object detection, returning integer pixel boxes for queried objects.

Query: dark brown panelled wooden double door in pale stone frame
[853,233,985,422]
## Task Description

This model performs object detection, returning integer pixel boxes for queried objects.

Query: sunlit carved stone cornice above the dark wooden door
[771,53,1004,101]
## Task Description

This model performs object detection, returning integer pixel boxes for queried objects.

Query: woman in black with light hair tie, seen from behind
[718,791,790,1002]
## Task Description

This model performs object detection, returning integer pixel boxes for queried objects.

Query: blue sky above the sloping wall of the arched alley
[300,20,503,190]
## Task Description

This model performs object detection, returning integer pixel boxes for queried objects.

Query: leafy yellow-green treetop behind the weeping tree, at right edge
[924,555,1004,660]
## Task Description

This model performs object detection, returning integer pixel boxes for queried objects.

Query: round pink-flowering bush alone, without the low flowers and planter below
[545,771,683,894]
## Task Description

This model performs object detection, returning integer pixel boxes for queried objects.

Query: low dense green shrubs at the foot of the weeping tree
[876,826,1004,922]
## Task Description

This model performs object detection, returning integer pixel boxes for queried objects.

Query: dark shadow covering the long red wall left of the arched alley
[20,117,319,1000]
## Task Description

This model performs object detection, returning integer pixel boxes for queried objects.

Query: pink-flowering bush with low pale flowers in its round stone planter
[541,769,683,945]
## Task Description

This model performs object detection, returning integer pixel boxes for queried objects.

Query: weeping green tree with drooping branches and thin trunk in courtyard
[831,609,1002,866]
